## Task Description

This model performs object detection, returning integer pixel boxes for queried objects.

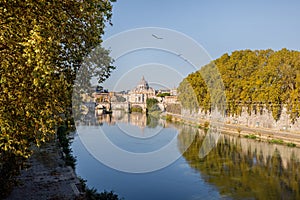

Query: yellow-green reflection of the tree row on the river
[178,129,300,199]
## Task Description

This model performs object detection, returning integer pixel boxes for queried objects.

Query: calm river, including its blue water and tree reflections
[72,112,300,200]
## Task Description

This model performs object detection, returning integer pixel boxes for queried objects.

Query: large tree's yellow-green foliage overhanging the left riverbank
[0,0,112,159]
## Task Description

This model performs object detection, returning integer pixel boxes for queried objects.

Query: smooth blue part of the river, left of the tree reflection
[72,118,222,200]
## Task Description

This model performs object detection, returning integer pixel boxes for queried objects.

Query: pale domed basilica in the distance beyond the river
[129,76,155,103]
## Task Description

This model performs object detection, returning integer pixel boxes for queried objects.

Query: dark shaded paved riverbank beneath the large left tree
[6,141,81,200]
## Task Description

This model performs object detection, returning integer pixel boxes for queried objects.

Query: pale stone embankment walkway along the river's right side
[162,113,300,148]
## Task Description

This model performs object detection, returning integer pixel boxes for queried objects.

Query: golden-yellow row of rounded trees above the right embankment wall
[178,49,300,122]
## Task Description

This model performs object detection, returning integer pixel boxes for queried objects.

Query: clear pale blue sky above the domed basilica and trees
[98,0,300,91]
